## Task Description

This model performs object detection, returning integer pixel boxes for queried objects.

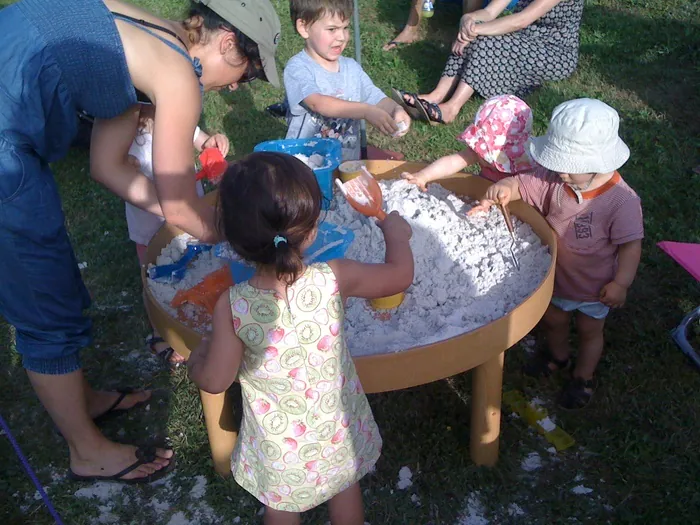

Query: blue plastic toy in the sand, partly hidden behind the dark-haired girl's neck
[214,222,355,283]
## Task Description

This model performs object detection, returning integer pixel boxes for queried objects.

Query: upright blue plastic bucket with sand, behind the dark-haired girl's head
[253,138,343,210]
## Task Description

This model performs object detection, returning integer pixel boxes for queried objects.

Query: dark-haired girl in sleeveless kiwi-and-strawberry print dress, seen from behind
[188,149,413,525]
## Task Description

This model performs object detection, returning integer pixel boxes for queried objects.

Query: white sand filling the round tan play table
[150,180,551,356]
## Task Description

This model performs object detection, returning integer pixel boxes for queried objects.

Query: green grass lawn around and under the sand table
[0,0,700,525]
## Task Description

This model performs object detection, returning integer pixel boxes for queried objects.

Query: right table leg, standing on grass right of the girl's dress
[469,352,505,467]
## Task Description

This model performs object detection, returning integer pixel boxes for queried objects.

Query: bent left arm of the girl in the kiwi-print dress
[187,292,244,394]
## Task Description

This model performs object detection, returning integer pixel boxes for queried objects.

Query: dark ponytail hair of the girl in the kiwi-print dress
[217,152,323,285]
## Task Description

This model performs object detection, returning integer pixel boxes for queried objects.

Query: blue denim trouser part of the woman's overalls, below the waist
[0,138,91,374]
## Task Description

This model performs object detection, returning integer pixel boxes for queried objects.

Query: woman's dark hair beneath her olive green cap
[182,2,267,80]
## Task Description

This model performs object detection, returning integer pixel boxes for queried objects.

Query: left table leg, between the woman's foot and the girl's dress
[199,390,238,477]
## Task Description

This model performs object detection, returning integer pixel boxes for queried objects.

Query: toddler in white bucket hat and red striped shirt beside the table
[470,98,644,408]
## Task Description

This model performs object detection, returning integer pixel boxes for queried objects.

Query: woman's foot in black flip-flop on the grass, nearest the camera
[70,439,173,480]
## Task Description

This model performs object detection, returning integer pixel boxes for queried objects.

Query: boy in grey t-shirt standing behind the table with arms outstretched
[284,0,411,160]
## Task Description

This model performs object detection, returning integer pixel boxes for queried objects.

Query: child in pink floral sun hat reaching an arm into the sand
[401,95,534,191]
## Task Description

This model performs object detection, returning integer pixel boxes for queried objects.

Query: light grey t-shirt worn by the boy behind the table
[284,51,386,160]
